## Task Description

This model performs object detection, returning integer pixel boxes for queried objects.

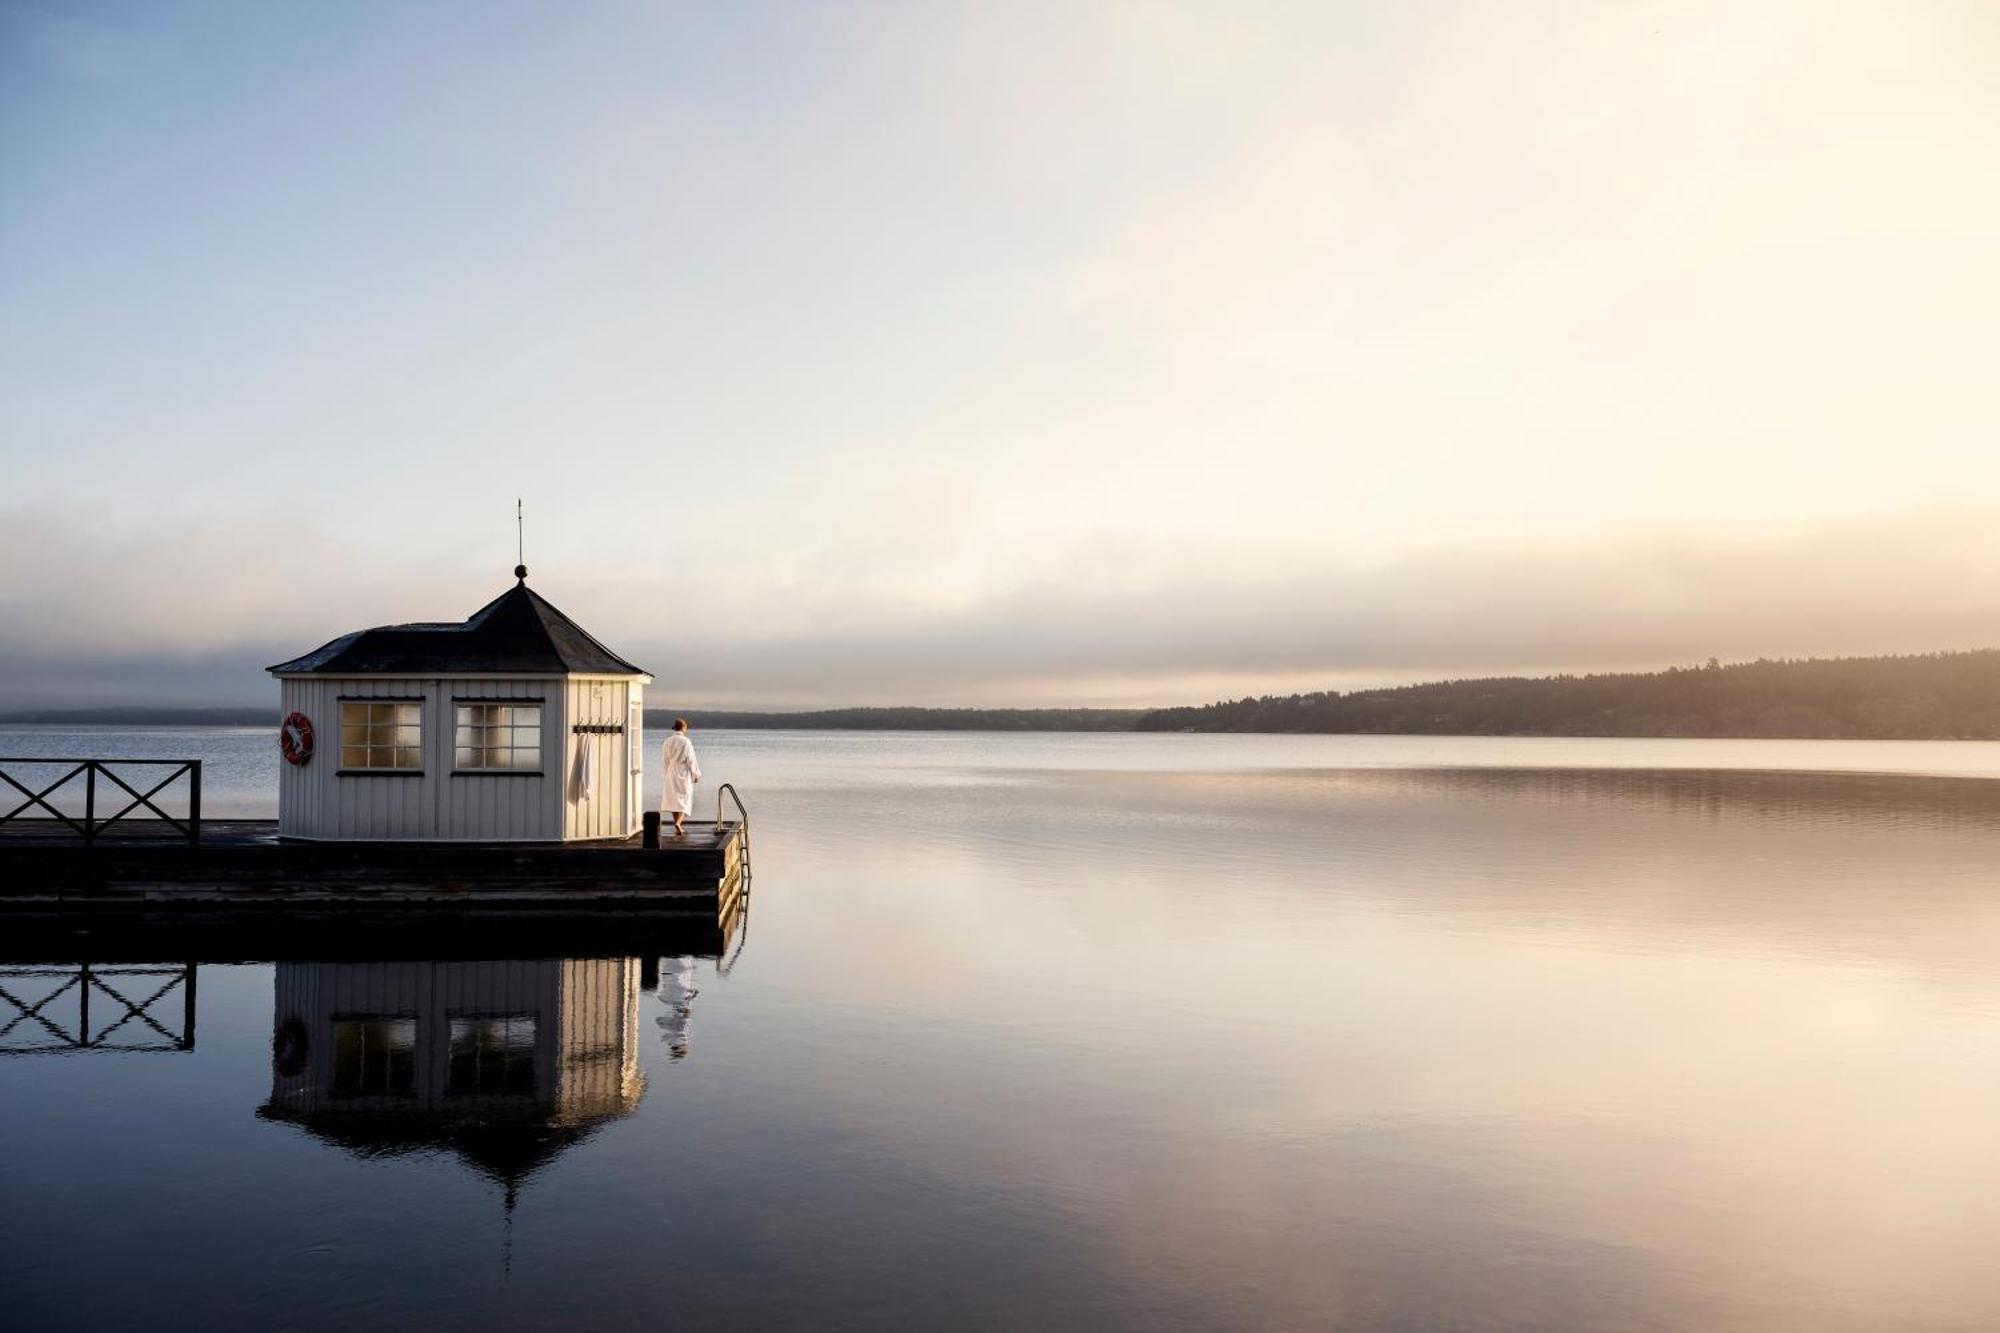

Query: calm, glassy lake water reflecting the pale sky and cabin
[0,729,2000,1333]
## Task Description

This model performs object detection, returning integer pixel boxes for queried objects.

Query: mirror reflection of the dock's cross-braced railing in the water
[0,963,194,1055]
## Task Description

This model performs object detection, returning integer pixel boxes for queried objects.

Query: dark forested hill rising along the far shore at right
[1136,648,2000,741]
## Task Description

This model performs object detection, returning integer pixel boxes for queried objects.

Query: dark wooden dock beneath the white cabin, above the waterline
[0,819,748,925]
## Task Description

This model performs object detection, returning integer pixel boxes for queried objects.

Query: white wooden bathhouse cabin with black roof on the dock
[270,566,652,843]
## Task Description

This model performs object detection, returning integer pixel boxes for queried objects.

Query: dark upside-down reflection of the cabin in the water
[260,959,646,1195]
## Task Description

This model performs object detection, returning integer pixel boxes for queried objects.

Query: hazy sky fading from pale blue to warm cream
[0,0,2000,709]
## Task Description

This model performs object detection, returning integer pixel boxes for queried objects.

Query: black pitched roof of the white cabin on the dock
[266,582,650,677]
